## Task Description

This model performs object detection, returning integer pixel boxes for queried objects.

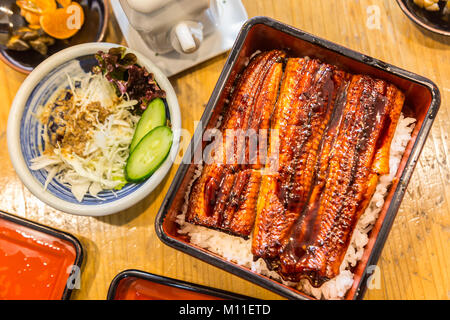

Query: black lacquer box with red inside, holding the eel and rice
[155,17,440,300]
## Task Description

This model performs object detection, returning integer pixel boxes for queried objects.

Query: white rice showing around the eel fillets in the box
[177,114,416,299]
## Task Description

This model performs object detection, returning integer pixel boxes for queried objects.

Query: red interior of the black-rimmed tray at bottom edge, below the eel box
[114,277,222,300]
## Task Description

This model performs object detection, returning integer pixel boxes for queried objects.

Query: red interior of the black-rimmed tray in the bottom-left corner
[0,215,77,300]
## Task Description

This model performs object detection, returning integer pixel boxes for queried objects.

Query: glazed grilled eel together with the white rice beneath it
[179,50,414,297]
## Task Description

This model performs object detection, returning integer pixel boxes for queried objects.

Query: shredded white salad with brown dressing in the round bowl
[31,74,139,202]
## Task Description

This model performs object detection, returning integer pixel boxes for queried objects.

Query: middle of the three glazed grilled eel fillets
[252,58,347,262]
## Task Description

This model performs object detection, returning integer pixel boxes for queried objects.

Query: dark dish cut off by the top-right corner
[397,0,450,36]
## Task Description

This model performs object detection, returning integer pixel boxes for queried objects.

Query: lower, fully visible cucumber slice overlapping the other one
[125,126,173,182]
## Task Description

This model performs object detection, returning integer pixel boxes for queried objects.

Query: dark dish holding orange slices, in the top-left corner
[0,0,109,74]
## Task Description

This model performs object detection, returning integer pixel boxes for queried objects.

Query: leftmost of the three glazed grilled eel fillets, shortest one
[186,50,285,238]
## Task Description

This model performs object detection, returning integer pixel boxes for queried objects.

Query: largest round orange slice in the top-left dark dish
[40,2,84,39]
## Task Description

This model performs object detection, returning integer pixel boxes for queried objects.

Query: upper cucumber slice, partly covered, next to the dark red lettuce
[130,98,167,153]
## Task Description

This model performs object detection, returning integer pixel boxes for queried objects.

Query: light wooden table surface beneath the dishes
[0,0,450,299]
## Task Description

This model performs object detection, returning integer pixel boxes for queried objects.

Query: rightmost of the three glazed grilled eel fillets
[277,75,404,286]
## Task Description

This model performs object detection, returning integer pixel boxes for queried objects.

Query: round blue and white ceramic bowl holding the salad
[7,43,181,216]
